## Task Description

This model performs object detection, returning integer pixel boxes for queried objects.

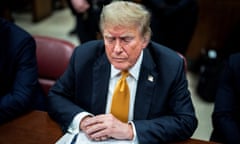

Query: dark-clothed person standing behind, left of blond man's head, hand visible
[67,0,111,43]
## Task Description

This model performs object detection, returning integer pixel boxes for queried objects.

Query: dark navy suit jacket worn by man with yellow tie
[49,41,197,143]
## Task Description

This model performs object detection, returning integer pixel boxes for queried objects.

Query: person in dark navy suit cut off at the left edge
[0,18,43,124]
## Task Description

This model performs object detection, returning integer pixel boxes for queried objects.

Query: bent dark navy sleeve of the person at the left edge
[0,30,38,124]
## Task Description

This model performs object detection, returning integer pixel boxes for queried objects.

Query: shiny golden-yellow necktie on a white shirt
[111,71,130,122]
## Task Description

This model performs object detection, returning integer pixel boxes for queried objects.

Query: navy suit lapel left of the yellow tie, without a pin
[92,54,110,114]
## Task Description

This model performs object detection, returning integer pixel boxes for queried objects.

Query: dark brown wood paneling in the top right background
[186,0,240,60]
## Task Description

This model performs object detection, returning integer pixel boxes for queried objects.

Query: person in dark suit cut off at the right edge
[211,53,240,144]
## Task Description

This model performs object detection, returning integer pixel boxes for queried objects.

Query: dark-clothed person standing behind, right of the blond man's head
[141,0,198,55]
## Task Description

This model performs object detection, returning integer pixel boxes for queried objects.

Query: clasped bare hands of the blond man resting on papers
[80,114,133,141]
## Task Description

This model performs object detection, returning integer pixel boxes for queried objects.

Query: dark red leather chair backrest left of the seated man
[34,36,75,95]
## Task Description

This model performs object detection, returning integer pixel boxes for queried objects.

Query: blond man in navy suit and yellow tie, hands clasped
[49,1,197,143]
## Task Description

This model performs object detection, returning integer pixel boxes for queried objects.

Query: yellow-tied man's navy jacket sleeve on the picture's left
[48,47,84,132]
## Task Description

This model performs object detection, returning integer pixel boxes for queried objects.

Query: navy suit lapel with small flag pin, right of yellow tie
[134,48,158,120]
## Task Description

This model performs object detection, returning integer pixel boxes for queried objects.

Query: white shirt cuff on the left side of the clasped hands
[67,112,93,134]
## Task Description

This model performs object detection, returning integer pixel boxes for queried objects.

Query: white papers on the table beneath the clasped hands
[56,132,134,144]
